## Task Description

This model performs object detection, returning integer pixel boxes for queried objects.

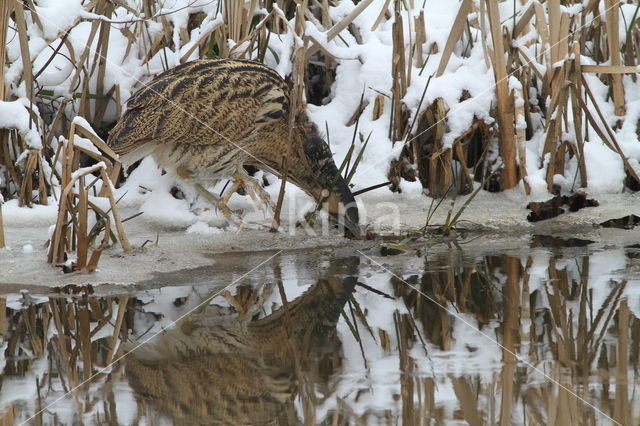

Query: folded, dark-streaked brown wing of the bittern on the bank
[109,61,288,158]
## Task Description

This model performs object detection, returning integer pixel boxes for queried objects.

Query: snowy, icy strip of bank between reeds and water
[0,185,640,291]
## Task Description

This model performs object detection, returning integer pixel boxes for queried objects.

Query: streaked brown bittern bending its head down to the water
[108,59,360,238]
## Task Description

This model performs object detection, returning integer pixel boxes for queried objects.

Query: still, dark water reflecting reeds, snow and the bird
[0,237,640,425]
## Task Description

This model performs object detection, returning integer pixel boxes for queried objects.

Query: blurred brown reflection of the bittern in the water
[125,258,358,425]
